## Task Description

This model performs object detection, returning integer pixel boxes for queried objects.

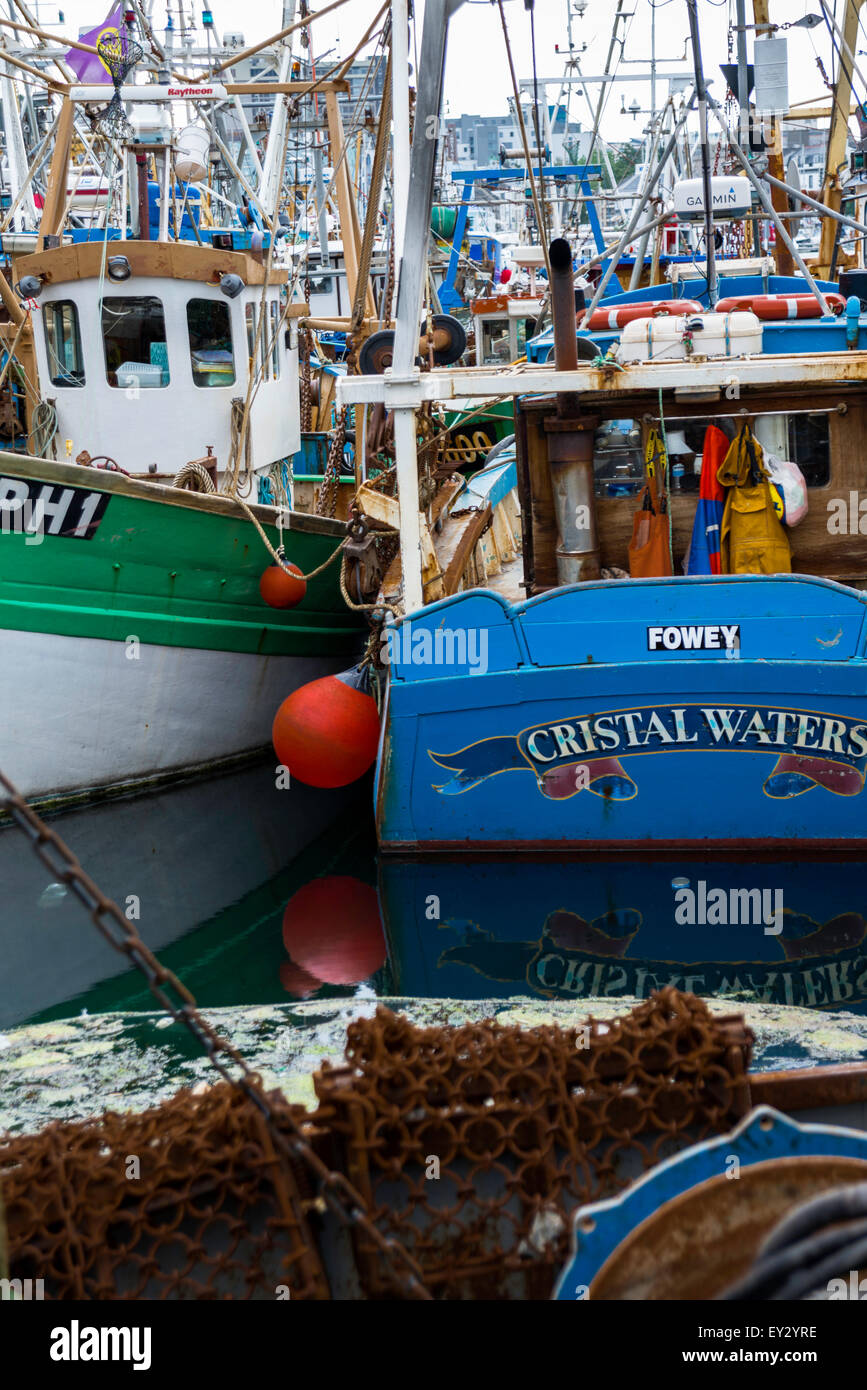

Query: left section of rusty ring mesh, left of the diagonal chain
[0,1083,328,1300]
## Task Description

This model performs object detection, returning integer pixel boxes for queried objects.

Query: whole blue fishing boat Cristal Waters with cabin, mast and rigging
[339,0,867,853]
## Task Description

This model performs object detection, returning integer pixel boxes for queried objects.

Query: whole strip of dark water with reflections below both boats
[0,765,867,1027]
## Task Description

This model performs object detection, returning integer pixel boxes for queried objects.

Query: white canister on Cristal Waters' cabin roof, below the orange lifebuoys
[618,309,761,361]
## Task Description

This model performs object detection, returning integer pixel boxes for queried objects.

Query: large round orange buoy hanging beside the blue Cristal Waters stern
[271,671,379,787]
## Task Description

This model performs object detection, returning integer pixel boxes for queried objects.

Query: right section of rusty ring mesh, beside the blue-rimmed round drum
[314,988,753,1298]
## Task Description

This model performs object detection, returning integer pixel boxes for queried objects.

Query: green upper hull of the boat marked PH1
[0,468,364,656]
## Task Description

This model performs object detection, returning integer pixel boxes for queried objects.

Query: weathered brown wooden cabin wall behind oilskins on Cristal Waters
[515,381,867,595]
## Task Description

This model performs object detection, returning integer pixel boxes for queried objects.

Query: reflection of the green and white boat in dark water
[0,762,374,1029]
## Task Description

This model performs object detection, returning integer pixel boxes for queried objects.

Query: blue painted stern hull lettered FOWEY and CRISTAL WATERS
[377,575,867,852]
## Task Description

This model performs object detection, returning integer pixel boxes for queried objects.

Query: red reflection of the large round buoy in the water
[281,876,385,984]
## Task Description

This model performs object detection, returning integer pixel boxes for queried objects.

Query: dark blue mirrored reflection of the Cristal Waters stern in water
[379,856,867,1012]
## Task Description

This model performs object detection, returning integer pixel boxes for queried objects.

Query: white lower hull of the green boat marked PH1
[0,630,346,798]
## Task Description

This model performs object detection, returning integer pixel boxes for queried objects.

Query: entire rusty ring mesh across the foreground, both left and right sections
[0,988,753,1300]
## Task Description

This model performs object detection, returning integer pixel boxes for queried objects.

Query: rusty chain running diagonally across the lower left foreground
[0,771,431,1300]
